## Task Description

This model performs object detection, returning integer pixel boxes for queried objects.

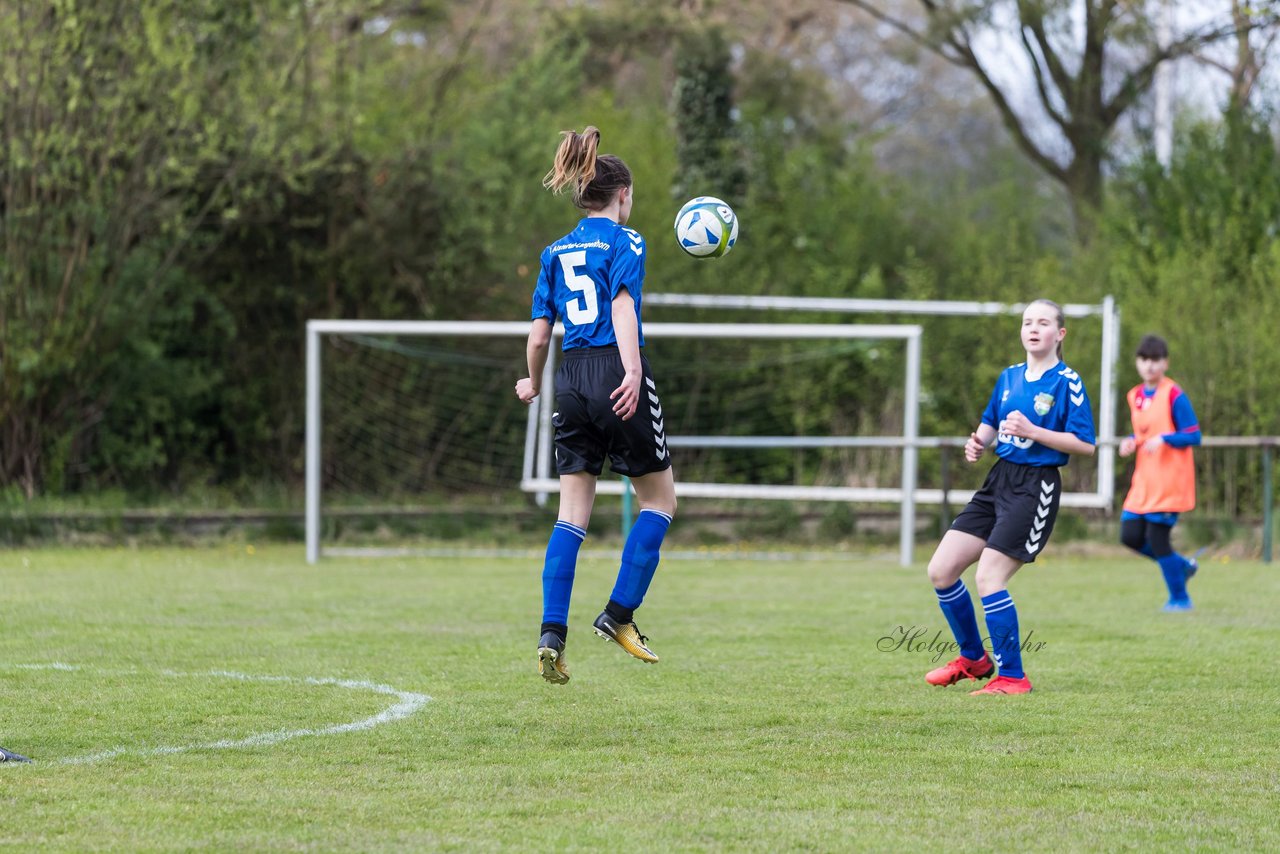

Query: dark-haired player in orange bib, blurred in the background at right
[1120,335,1201,611]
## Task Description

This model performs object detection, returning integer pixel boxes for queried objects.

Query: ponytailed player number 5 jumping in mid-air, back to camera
[516,127,676,685]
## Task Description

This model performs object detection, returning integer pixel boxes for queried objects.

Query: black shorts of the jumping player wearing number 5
[552,347,671,478]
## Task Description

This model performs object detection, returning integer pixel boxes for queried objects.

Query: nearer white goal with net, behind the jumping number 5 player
[307,320,922,561]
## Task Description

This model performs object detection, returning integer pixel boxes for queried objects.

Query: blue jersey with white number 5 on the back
[532,216,645,350]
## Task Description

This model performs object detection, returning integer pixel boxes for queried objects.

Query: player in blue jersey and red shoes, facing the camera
[924,300,1097,694]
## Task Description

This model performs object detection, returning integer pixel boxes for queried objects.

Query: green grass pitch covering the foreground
[0,544,1280,851]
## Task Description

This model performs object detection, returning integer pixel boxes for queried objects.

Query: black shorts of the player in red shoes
[951,460,1062,563]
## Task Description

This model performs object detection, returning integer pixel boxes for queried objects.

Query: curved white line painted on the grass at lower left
[15,662,431,764]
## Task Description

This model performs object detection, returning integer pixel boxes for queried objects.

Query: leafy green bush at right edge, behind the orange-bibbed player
[1107,113,1280,435]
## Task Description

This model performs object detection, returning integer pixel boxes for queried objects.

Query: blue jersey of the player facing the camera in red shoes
[982,362,1097,466]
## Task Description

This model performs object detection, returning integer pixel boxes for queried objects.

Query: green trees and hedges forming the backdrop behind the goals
[0,0,1280,517]
